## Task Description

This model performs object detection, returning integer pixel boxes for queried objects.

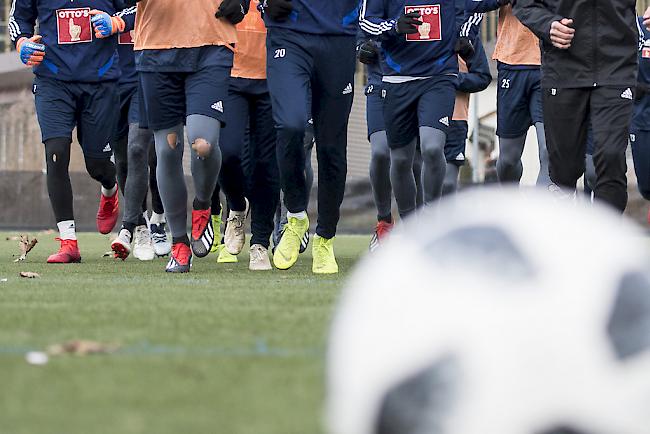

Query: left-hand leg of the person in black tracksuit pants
[543,89,591,199]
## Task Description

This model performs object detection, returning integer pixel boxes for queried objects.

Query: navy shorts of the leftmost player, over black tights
[33,76,120,158]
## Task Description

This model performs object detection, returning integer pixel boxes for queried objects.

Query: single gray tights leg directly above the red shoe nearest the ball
[370,131,393,220]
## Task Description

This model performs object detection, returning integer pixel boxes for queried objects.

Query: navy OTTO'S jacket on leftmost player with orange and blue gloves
[9,0,134,83]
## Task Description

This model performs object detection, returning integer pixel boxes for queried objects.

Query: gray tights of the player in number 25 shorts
[497,122,551,187]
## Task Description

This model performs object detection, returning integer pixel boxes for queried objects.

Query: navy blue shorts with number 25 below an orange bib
[497,65,544,139]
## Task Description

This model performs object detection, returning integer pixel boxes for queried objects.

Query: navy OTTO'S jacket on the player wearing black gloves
[359,0,480,77]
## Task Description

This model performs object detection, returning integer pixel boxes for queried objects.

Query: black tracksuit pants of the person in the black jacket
[543,87,634,212]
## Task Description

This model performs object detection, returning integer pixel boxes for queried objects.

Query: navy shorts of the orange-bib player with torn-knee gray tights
[140,46,233,131]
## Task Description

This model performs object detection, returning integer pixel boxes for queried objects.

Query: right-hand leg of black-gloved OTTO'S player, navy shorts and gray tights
[415,77,456,205]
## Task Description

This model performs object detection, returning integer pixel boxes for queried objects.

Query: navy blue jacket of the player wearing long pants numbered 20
[264,0,359,36]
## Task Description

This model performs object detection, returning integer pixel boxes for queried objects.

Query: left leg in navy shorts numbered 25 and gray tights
[497,67,532,184]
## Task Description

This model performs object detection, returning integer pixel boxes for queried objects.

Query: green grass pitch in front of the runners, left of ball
[0,233,368,434]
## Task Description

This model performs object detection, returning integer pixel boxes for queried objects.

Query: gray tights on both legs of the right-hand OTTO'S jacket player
[390,127,447,217]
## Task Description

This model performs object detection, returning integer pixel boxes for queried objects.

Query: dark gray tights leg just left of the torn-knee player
[124,123,153,225]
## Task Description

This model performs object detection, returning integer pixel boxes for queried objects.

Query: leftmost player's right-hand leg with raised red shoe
[77,82,120,234]
